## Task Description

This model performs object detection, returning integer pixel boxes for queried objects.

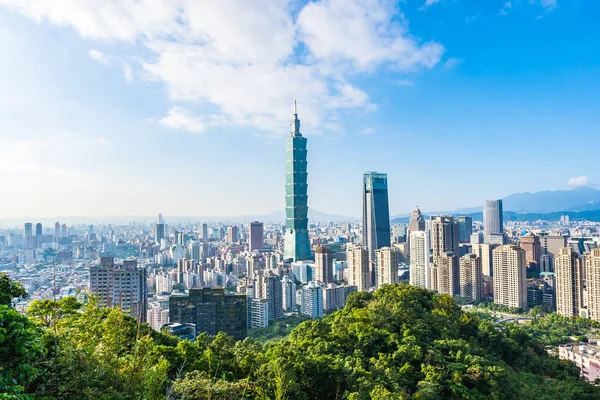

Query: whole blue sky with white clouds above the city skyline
[0,0,600,217]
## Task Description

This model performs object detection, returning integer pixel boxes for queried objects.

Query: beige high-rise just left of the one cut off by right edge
[554,247,589,317]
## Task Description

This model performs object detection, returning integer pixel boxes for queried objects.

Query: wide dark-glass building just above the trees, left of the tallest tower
[169,287,248,340]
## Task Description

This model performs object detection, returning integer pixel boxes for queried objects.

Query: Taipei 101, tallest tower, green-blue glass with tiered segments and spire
[283,101,310,261]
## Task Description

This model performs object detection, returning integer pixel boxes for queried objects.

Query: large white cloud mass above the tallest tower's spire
[0,0,445,134]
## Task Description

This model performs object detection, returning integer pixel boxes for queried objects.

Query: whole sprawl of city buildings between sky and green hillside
[0,105,600,350]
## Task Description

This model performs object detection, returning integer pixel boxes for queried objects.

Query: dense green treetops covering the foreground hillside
[0,285,600,400]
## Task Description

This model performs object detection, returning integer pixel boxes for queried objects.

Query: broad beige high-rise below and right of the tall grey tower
[492,244,527,309]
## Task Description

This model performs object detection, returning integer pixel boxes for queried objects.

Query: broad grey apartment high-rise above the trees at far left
[90,257,148,322]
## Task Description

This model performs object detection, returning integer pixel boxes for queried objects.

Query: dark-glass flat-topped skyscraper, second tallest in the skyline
[362,172,392,286]
